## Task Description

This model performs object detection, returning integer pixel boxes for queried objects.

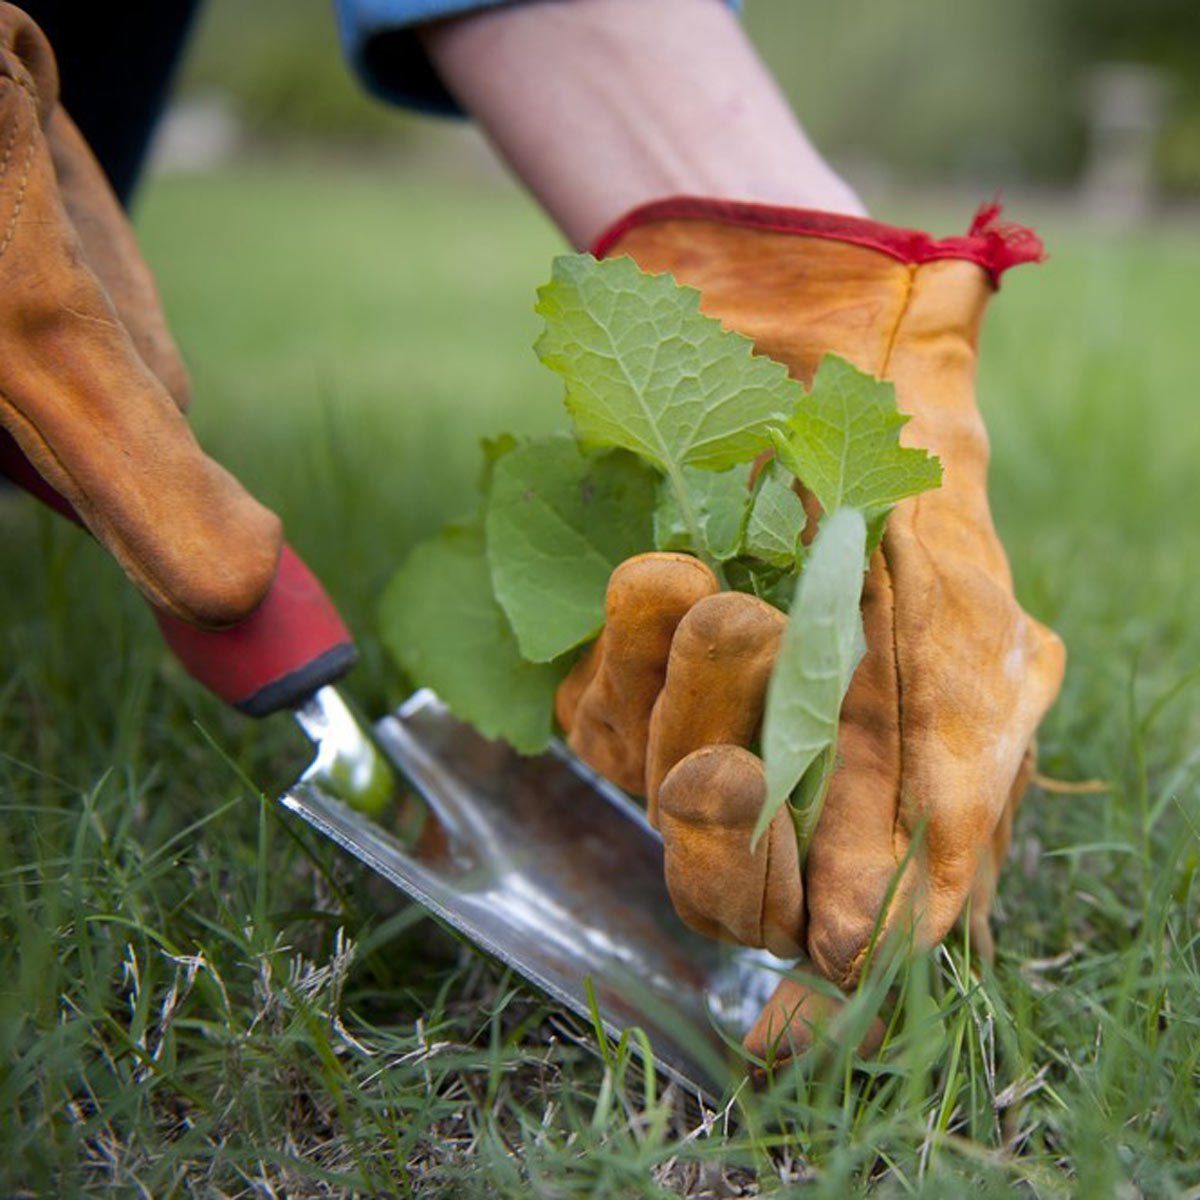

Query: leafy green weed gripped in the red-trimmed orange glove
[382,254,941,851]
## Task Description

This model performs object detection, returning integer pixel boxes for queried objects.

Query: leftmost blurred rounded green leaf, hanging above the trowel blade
[379,527,566,754]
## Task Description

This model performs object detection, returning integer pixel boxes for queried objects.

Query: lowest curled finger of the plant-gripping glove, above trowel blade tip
[659,745,804,958]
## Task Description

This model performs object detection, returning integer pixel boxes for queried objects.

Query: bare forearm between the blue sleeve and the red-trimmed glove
[422,0,863,246]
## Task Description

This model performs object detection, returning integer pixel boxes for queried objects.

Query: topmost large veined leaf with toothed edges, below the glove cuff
[536,254,803,472]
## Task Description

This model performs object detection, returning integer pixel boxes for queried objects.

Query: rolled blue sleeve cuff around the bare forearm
[334,0,742,116]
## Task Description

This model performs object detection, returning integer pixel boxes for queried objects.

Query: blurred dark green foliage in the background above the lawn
[175,0,1200,196]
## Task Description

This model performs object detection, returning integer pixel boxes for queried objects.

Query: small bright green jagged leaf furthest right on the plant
[772,354,942,541]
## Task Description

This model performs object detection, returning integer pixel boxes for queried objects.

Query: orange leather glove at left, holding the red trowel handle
[0,2,282,626]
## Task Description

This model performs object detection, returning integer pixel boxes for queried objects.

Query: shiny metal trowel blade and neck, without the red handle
[281,689,782,1096]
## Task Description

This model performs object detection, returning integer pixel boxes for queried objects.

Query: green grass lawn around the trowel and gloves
[0,168,1200,1196]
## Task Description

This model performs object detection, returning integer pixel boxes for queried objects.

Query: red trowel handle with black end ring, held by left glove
[0,430,356,716]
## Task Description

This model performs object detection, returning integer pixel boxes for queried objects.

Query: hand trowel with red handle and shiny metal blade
[0,433,782,1098]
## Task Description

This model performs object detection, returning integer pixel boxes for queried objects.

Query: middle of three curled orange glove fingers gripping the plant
[646,592,787,824]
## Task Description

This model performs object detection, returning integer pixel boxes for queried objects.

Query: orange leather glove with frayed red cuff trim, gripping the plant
[558,199,1064,1057]
